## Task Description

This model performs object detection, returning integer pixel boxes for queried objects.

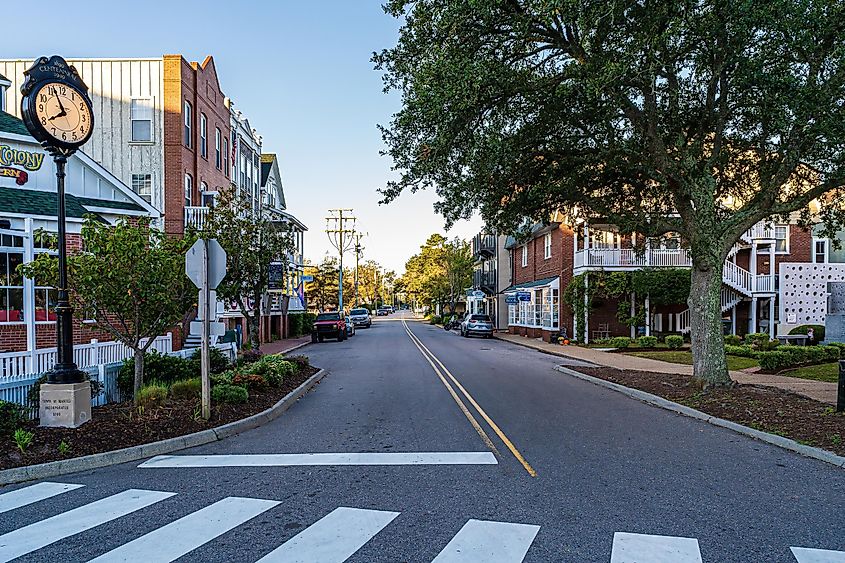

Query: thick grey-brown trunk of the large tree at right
[688,266,733,388]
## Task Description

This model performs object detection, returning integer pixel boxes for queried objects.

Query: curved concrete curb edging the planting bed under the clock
[0,369,328,485]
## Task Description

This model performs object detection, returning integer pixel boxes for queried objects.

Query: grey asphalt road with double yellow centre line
[0,314,845,563]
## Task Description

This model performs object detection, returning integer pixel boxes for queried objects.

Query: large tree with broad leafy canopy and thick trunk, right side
[374,0,845,386]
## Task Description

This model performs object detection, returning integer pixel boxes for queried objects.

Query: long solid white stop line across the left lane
[138,452,498,468]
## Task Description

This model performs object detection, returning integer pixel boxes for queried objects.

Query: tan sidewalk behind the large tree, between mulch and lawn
[495,333,836,405]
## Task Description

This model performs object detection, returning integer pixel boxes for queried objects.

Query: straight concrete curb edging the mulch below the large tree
[555,366,845,468]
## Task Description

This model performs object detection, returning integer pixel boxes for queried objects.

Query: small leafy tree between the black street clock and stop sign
[18,217,196,397]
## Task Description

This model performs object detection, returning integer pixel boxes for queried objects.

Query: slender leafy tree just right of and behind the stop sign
[204,194,294,350]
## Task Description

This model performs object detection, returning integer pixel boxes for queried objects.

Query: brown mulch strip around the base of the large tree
[577,367,845,456]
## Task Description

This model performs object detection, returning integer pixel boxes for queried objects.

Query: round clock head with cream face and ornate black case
[21,55,94,156]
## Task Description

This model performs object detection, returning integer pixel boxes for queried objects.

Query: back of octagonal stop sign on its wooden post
[185,239,226,420]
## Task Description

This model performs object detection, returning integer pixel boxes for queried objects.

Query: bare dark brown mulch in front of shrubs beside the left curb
[0,366,319,469]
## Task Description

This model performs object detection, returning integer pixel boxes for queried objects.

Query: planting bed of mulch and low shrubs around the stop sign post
[0,356,319,469]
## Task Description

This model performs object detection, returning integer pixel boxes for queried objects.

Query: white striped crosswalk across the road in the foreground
[0,483,845,563]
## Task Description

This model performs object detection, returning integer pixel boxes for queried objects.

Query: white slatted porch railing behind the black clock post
[0,332,173,378]
